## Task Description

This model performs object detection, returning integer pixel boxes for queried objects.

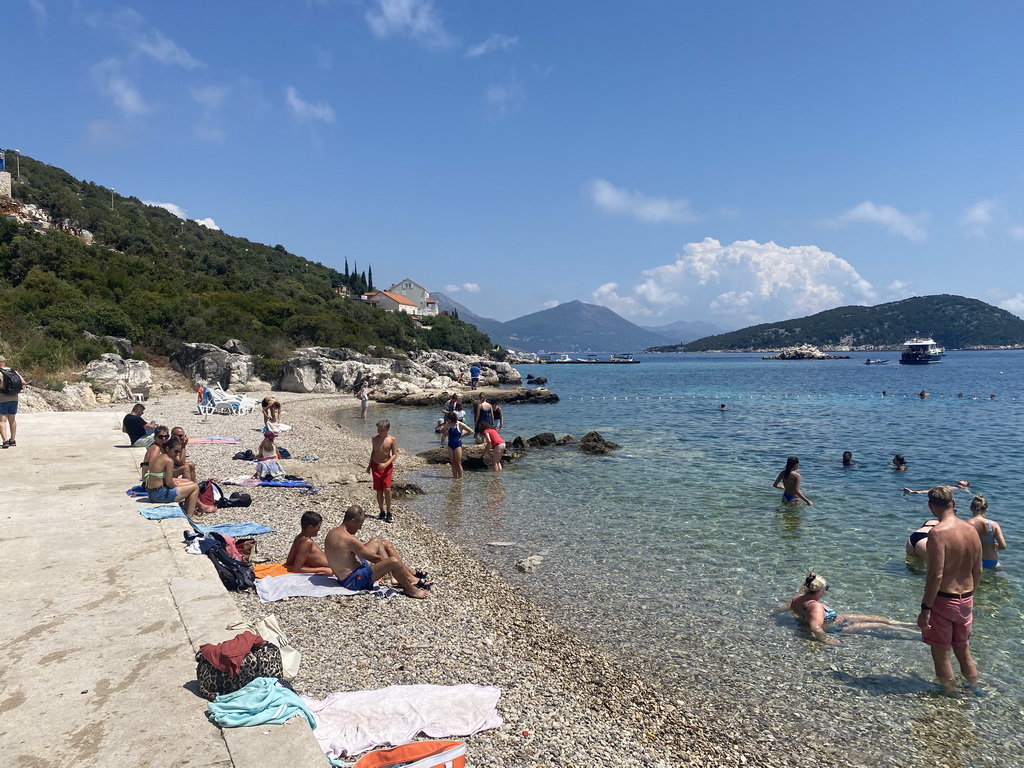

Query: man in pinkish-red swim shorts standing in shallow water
[918,485,981,695]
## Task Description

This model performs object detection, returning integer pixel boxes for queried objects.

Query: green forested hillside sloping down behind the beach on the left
[0,156,490,372]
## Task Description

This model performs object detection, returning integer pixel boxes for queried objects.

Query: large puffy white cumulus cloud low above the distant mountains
[592,238,906,325]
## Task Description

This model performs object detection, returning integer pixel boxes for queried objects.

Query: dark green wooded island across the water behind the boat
[644,294,1024,352]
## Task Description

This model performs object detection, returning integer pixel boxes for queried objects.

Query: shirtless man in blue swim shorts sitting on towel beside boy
[324,505,430,600]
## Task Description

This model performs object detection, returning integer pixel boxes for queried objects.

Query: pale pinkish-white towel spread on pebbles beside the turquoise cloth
[299,684,504,760]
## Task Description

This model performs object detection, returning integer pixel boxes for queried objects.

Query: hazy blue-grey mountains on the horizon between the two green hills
[430,293,679,352]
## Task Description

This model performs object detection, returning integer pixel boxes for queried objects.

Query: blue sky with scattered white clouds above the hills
[6,0,1024,328]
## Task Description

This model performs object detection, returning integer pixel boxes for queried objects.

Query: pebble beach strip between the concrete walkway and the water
[132,394,802,768]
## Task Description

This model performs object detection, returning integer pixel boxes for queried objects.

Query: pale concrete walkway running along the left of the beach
[0,412,327,768]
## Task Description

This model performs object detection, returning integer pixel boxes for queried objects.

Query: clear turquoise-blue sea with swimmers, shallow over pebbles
[342,351,1024,766]
